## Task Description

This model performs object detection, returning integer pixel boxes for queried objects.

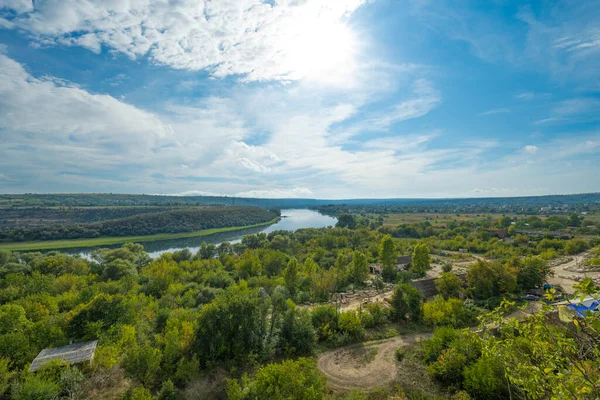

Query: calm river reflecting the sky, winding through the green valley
[69,209,337,259]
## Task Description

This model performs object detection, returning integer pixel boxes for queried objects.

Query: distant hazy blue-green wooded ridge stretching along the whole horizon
[0,193,600,214]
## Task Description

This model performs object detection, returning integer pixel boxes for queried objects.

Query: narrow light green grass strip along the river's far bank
[0,217,279,251]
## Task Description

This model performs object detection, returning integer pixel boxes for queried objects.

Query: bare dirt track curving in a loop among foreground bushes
[317,333,431,392]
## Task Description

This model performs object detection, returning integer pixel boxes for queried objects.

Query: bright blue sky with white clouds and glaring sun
[0,0,600,199]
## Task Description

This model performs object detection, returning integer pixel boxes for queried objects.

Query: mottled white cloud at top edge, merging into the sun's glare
[3,0,365,81]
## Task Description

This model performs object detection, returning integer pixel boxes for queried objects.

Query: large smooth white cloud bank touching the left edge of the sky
[0,54,172,152]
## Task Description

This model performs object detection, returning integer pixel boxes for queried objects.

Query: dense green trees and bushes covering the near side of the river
[0,212,600,400]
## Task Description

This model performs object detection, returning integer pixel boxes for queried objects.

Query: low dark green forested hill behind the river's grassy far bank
[0,207,278,241]
